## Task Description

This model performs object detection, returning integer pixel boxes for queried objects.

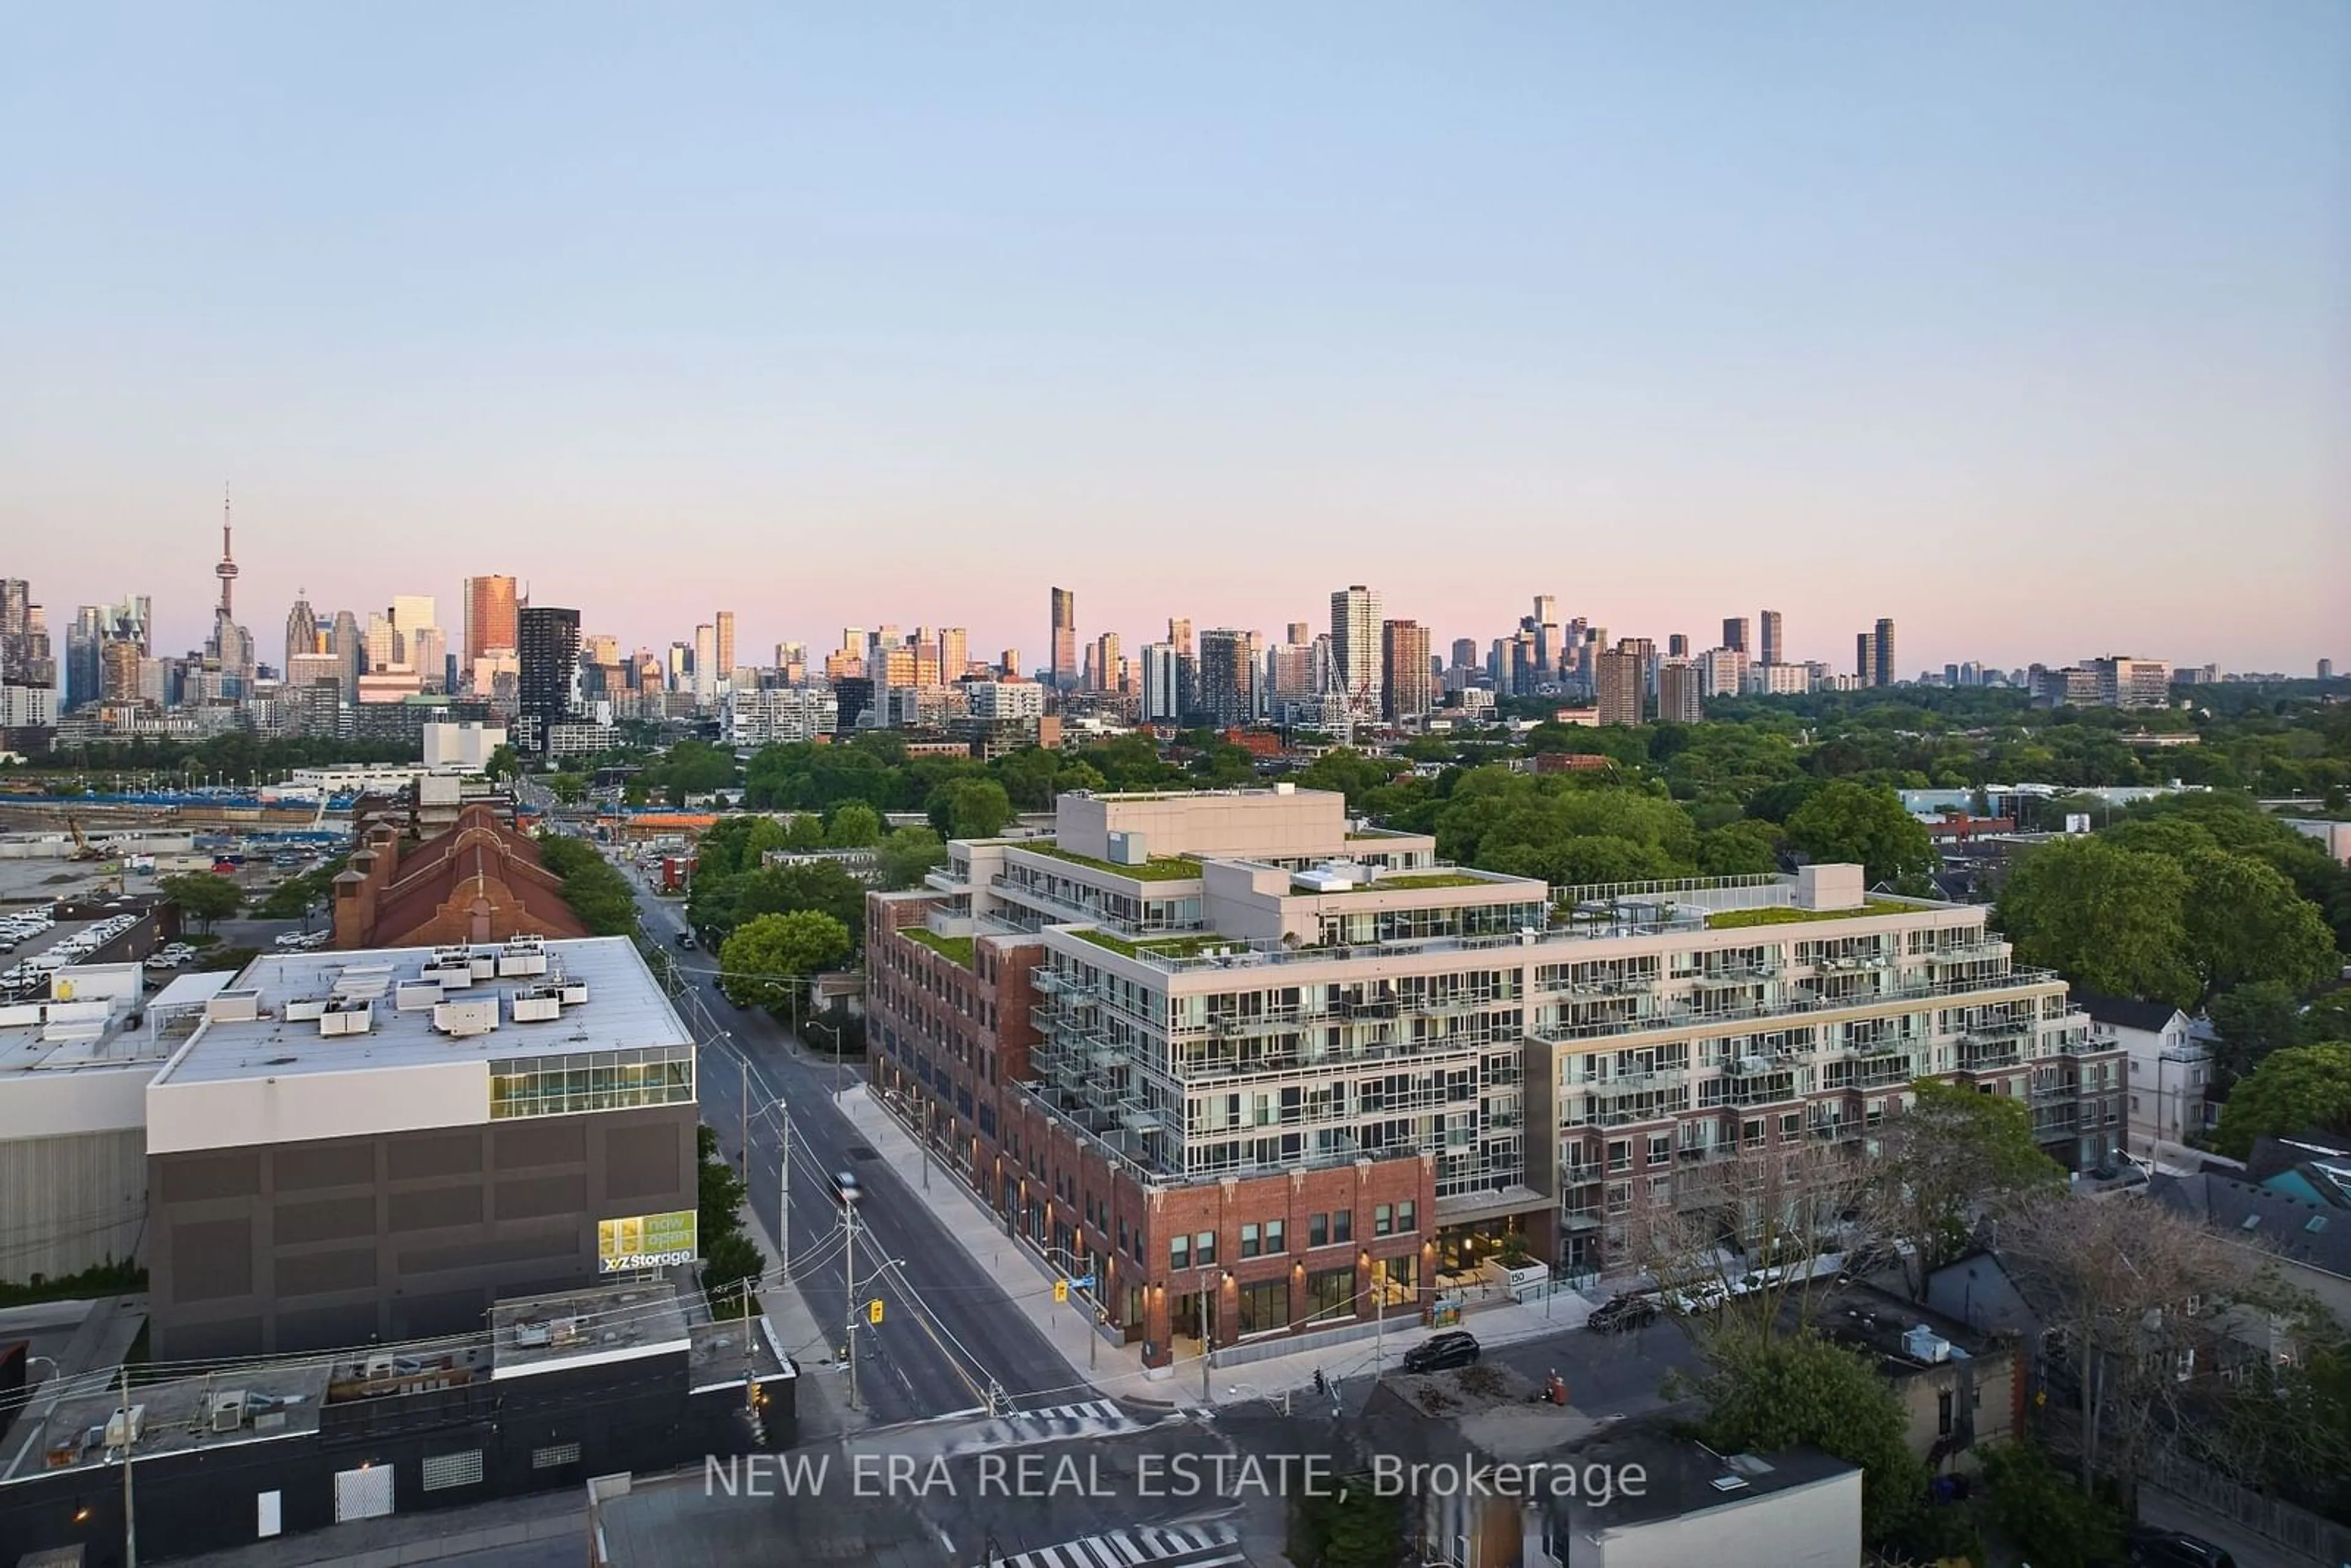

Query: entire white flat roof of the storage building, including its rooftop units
[155,936,694,1089]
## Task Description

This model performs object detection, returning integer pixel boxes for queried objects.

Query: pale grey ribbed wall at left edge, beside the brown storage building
[0,1126,148,1283]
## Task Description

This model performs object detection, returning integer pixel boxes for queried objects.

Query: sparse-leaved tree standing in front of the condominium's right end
[1864,1079,2064,1300]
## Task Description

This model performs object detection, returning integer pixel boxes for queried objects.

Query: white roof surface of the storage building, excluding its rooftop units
[155,936,694,1089]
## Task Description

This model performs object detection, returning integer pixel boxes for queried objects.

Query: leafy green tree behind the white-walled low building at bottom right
[1697,1333,1925,1542]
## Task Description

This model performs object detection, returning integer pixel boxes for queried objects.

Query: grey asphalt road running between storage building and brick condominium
[616,882,1093,1422]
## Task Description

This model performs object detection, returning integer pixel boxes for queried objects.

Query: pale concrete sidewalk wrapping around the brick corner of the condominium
[832,1084,1592,1408]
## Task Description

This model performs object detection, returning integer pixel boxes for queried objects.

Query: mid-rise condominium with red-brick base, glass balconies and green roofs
[868,785,2123,1366]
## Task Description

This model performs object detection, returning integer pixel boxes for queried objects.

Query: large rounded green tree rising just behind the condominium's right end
[1998,837,2198,1006]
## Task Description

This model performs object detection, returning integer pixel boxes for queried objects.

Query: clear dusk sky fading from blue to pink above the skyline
[0,0,2351,675]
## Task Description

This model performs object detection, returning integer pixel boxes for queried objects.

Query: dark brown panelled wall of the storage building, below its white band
[148,1105,698,1359]
